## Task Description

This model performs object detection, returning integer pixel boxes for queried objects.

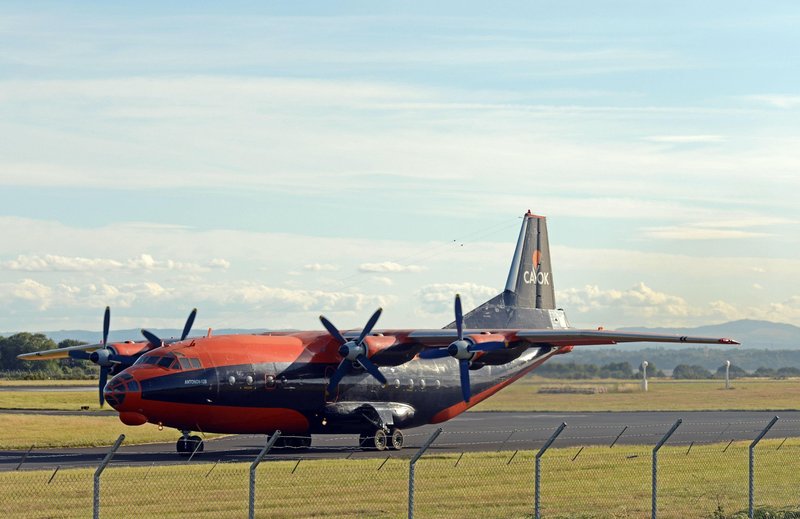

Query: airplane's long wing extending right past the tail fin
[408,328,739,347]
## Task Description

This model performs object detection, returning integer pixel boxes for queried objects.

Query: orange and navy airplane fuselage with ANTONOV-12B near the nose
[106,332,558,434]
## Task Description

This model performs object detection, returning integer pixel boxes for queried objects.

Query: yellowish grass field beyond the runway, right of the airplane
[473,377,800,412]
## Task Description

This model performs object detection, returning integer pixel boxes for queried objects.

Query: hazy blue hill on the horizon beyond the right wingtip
[622,319,800,350]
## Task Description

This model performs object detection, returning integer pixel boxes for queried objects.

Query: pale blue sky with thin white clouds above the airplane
[0,1,800,331]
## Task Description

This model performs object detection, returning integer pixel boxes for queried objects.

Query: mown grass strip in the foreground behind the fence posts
[0,439,800,519]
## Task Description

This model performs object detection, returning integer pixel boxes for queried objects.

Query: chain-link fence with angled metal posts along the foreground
[0,420,800,519]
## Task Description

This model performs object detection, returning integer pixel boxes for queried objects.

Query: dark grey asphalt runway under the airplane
[0,411,800,471]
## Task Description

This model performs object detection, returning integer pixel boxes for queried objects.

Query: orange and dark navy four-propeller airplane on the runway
[19,211,738,454]
